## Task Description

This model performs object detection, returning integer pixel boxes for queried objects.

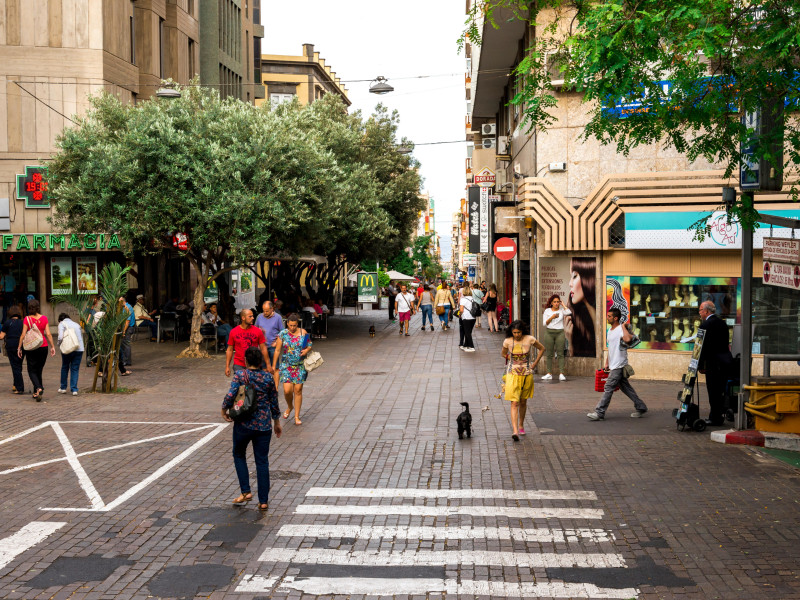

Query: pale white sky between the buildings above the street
[261,0,467,264]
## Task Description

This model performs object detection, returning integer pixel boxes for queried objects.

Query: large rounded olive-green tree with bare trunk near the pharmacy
[48,85,419,354]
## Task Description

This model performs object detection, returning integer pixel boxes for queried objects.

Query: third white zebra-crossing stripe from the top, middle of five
[278,525,614,543]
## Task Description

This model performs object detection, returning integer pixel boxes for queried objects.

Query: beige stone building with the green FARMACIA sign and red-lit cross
[0,0,198,316]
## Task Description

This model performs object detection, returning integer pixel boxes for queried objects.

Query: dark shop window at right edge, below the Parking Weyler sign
[752,278,800,354]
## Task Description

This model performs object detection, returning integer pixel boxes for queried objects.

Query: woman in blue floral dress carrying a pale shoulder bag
[272,313,311,425]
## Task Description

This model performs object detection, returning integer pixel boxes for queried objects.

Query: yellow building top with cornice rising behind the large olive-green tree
[256,44,351,106]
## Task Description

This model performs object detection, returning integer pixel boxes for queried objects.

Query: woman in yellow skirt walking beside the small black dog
[502,320,544,442]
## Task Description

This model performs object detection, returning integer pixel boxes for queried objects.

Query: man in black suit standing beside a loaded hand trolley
[698,300,733,425]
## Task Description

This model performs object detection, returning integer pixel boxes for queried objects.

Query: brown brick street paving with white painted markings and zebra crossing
[0,313,800,600]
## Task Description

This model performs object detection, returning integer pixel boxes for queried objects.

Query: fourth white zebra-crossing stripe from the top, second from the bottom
[258,548,626,569]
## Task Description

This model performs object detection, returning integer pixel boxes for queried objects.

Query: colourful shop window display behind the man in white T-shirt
[606,275,741,351]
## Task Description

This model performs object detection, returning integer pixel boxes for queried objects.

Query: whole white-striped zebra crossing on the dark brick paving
[236,487,639,598]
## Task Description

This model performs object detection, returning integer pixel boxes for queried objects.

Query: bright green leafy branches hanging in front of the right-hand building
[460,0,800,227]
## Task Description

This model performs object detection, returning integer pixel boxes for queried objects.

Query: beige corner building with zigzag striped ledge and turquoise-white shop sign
[467,4,800,380]
